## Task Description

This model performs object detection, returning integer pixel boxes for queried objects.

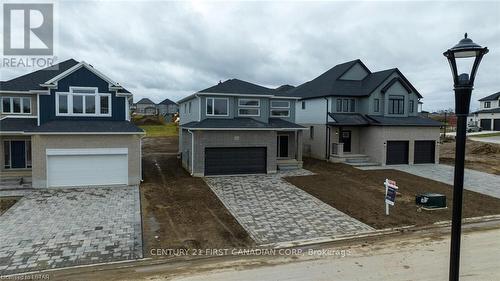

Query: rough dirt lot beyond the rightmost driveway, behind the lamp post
[439,140,500,175]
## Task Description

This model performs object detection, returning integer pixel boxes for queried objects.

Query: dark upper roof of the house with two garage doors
[288,59,422,99]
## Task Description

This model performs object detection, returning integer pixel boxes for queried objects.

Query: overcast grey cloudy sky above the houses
[1,1,500,110]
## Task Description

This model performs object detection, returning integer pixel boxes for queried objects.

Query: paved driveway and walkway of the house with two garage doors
[358,164,500,198]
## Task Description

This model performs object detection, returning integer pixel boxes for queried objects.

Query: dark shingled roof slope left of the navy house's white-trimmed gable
[0,59,78,91]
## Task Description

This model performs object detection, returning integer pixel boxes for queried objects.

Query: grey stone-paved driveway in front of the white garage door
[0,186,142,276]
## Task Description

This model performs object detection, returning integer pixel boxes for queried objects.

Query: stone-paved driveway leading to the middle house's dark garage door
[205,170,373,245]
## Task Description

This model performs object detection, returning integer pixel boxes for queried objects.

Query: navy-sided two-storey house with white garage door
[0,59,144,188]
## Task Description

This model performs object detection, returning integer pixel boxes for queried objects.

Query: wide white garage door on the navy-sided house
[47,148,128,187]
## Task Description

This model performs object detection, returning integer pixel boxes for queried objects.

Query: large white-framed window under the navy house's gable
[56,87,111,116]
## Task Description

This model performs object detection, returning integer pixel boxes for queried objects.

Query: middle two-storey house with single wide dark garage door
[178,79,305,176]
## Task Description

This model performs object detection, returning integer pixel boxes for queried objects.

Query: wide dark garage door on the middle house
[205,147,267,176]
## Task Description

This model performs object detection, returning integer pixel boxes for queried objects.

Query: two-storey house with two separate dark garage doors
[286,60,441,166]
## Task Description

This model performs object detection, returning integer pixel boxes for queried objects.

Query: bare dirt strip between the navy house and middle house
[141,137,254,257]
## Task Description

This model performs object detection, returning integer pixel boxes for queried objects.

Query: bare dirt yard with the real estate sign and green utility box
[287,159,500,229]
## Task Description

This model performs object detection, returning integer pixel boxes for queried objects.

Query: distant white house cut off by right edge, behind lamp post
[474,92,500,131]
